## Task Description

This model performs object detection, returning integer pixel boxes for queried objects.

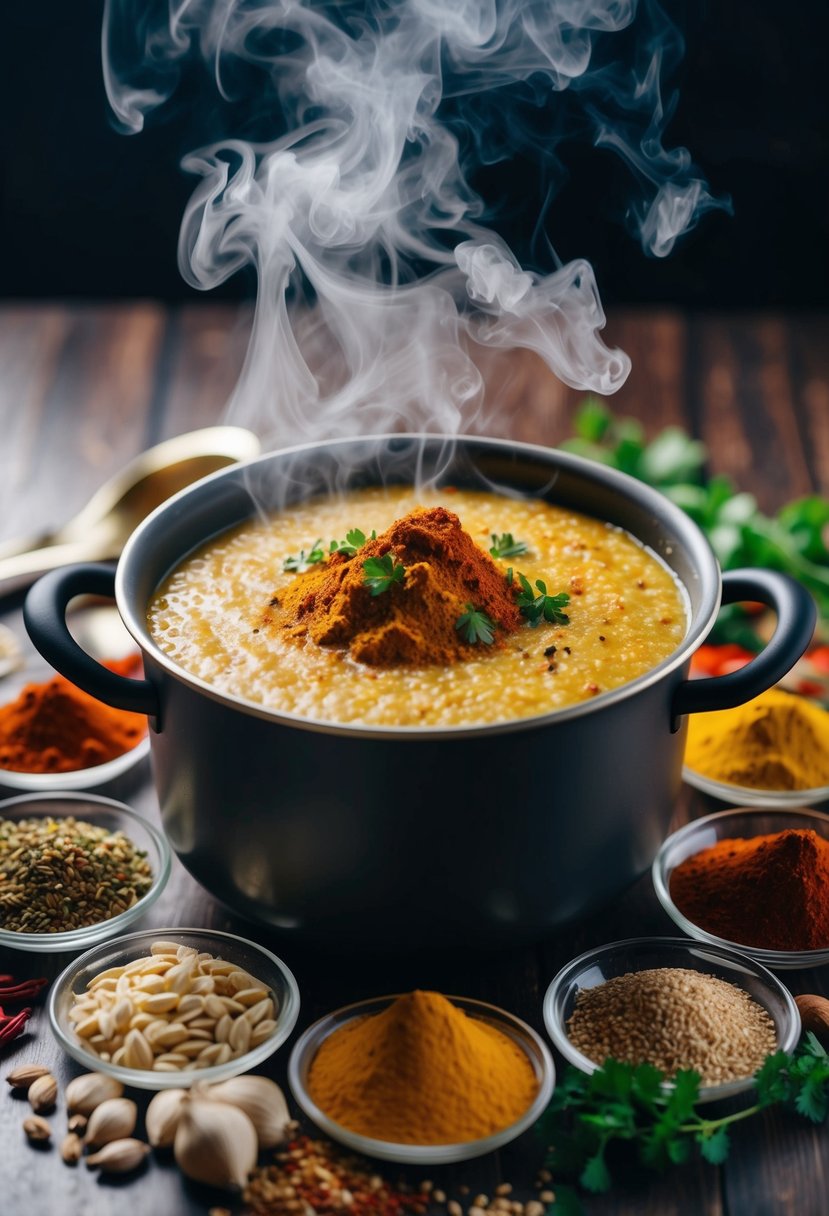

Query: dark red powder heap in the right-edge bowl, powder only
[670,829,829,950]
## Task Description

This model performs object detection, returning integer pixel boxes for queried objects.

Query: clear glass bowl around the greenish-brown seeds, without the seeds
[0,794,170,953]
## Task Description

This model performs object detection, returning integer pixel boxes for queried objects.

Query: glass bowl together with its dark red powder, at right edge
[652,807,829,970]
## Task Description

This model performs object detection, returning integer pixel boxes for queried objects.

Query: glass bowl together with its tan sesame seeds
[543,938,800,1102]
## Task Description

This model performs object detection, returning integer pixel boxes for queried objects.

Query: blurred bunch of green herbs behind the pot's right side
[562,398,829,649]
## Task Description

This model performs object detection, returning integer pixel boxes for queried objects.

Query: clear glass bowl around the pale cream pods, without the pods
[49,929,299,1090]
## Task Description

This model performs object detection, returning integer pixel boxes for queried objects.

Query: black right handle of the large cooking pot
[671,569,817,722]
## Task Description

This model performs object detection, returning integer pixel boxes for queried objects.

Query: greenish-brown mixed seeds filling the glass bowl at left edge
[0,816,153,929]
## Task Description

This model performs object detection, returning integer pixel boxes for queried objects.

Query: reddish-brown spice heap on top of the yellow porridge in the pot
[265,507,521,666]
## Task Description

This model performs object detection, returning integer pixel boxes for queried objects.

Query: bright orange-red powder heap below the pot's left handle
[0,657,147,772]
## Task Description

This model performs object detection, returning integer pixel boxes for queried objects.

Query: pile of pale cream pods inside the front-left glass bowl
[68,941,277,1073]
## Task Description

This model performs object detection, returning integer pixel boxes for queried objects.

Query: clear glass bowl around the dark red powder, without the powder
[652,806,829,970]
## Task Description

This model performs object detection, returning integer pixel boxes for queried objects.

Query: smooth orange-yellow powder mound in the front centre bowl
[308,991,538,1144]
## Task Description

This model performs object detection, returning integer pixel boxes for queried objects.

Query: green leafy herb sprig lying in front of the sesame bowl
[538,1034,829,1216]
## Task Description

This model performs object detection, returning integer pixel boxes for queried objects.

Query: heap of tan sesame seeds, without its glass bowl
[568,967,777,1085]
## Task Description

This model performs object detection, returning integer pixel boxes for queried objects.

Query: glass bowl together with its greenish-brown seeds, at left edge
[0,794,170,952]
